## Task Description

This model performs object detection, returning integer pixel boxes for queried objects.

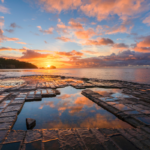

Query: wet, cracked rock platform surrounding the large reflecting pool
[0,75,150,150]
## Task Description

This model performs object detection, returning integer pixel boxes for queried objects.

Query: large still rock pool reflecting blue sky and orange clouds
[13,86,131,130]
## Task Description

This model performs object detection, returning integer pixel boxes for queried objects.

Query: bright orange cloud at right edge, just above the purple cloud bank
[134,35,150,52]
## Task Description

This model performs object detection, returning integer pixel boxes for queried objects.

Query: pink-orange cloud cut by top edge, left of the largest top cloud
[38,0,81,13]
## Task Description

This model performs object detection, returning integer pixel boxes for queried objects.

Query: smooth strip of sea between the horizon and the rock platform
[0,68,150,84]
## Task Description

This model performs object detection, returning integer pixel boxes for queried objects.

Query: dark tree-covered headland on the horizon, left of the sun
[0,58,38,69]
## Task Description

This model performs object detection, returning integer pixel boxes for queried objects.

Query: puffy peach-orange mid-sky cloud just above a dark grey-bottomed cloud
[75,28,97,39]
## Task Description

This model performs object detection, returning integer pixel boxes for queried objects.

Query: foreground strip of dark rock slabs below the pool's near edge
[0,128,150,150]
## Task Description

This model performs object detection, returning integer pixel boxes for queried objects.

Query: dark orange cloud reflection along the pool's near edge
[43,113,131,128]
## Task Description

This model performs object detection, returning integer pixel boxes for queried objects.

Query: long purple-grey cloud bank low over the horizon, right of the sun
[64,50,150,67]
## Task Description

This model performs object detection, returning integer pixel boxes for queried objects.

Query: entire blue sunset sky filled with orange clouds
[0,0,150,68]
